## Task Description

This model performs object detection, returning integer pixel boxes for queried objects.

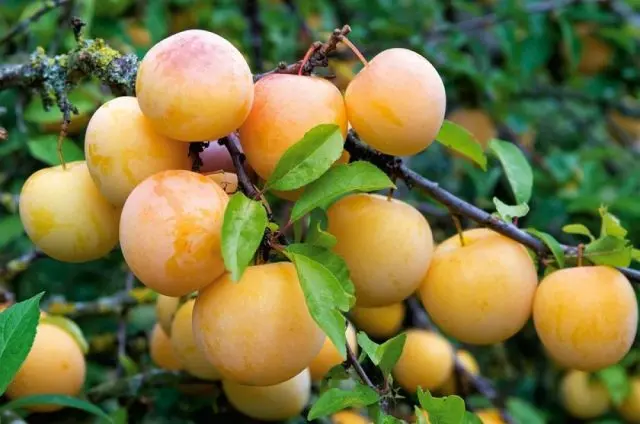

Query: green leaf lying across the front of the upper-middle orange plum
[265,124,344,191]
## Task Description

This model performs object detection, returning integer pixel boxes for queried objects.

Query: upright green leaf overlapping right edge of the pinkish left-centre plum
[222,191,269,281]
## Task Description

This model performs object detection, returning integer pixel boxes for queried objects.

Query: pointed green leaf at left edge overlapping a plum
[0,292,44,395]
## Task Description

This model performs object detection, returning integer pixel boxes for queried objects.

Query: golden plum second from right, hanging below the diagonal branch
[419,228,538,345]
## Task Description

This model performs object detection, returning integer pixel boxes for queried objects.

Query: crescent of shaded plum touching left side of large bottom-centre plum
[171,299,222,380]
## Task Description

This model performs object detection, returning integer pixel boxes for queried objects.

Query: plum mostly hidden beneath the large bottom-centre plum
[222,369,311,421]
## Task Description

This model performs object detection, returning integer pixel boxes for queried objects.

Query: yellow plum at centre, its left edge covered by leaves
[327,193,433,307]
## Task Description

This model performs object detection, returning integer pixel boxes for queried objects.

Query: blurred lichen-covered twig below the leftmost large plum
[43,288,156,318]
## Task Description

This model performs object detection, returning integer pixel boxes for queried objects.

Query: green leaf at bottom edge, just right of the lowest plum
[307,383,380,420]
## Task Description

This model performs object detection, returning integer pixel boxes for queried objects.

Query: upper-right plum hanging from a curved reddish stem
[344,48,447,156]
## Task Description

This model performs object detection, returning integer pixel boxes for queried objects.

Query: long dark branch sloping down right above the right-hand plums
[345,131,640,283]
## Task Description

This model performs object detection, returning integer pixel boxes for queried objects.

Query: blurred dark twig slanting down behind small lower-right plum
[405,296,513,423]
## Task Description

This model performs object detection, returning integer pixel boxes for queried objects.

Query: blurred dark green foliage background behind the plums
[0,0,640,424]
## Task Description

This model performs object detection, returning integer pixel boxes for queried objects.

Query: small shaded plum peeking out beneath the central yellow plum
[349,302,406,339]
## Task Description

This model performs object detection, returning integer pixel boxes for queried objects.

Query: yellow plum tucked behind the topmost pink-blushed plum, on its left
[84,97,191,207]
